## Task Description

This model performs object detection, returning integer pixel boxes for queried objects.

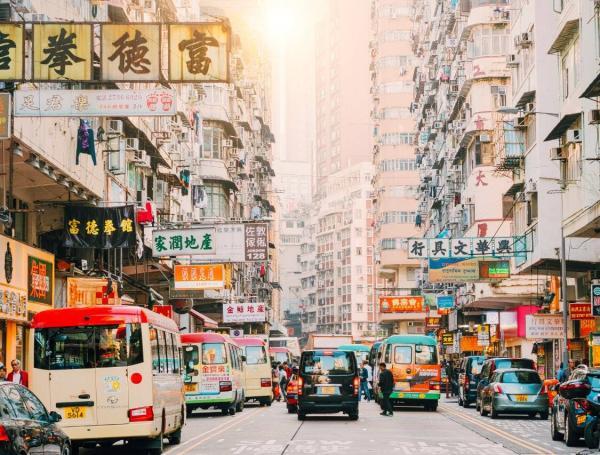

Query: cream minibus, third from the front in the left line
[236,338,273,406]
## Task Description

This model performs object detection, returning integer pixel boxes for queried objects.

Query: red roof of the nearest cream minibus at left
[31,305,179,333]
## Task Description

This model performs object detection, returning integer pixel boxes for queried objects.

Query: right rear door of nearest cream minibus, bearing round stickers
[94,324,134,425]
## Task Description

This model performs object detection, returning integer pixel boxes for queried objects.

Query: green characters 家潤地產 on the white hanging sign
[152,227,215,257]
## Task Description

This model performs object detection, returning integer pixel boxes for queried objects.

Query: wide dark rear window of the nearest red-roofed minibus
[33,324,144,370]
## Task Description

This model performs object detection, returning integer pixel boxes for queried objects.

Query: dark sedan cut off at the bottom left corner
[0,382,71,455]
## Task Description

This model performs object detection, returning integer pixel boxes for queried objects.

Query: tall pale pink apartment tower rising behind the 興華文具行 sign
[370,0,425,333]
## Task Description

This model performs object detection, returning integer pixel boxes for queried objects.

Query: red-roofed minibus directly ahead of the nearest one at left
[181,333,245,416]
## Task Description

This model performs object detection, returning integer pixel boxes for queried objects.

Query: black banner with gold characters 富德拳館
[64,205,135,248]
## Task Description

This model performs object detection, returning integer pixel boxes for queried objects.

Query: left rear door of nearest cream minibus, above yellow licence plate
[41,327,97,427]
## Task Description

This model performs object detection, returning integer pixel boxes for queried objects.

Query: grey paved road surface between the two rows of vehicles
[82,400,584,455]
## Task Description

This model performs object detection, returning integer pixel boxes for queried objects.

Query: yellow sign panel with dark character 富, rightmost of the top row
[169,23,230,82]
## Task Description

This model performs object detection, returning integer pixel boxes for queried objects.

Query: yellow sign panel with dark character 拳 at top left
[33,23,93,81]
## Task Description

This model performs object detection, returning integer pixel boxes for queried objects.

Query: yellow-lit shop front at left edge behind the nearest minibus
[0,235,54,365]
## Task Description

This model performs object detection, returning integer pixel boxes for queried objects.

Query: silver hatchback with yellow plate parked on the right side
[480,368,549,420]
